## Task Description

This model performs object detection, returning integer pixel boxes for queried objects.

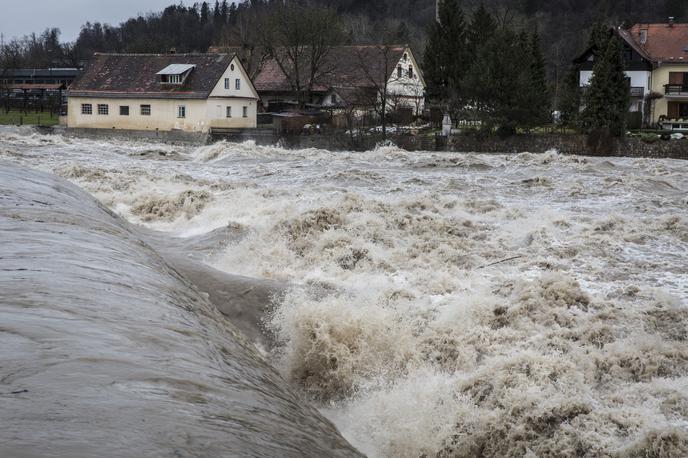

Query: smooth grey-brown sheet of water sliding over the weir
[0,162,359,457]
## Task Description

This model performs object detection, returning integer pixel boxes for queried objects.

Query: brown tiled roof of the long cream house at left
[69,54,234,99]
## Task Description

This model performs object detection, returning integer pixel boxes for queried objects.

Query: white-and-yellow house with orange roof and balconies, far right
[576,18,688,130]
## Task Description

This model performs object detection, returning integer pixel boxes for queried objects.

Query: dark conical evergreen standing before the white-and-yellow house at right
[584,37,630,137]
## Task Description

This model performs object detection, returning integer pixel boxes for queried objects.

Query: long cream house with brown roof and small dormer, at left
[67,54,259,132]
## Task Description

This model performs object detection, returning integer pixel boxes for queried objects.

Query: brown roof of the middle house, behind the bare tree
[254,45,412,92]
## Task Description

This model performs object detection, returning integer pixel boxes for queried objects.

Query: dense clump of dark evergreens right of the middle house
[424,0,551,134]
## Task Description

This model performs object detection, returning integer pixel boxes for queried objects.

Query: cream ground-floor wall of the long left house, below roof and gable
[67,97,257,132]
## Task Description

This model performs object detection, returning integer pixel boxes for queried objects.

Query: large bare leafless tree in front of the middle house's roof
[262,5,343,107]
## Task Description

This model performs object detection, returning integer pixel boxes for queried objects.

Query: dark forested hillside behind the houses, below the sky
[0,0,688,92]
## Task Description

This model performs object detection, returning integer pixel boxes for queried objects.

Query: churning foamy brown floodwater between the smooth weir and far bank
[0,128,688,457]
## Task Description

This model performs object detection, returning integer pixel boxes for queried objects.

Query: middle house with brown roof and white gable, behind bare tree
[254,45,426,114]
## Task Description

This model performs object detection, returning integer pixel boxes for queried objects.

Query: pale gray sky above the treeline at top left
[0,0,180,41]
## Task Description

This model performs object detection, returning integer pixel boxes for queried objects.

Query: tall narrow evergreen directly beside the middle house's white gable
[423,0,466,104]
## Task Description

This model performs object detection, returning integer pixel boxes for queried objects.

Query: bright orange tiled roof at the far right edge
[628,24,688,63]
